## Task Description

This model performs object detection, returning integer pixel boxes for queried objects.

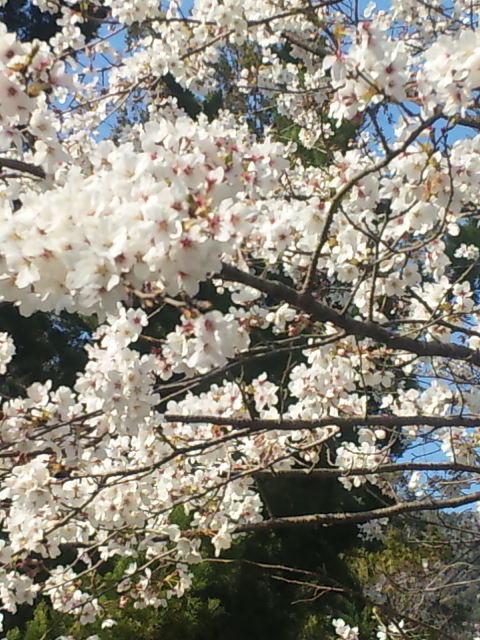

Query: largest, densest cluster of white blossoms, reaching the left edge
[0,117,286,314]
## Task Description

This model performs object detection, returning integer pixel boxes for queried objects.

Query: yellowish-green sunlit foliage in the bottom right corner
[342,514,480,640]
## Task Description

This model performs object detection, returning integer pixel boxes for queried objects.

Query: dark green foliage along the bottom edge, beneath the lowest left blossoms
[7,535,354,640]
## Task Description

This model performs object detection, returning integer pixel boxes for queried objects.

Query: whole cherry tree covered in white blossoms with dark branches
[0,0,480,639]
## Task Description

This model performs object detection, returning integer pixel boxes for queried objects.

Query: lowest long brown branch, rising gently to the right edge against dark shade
[235,491,480,533]
